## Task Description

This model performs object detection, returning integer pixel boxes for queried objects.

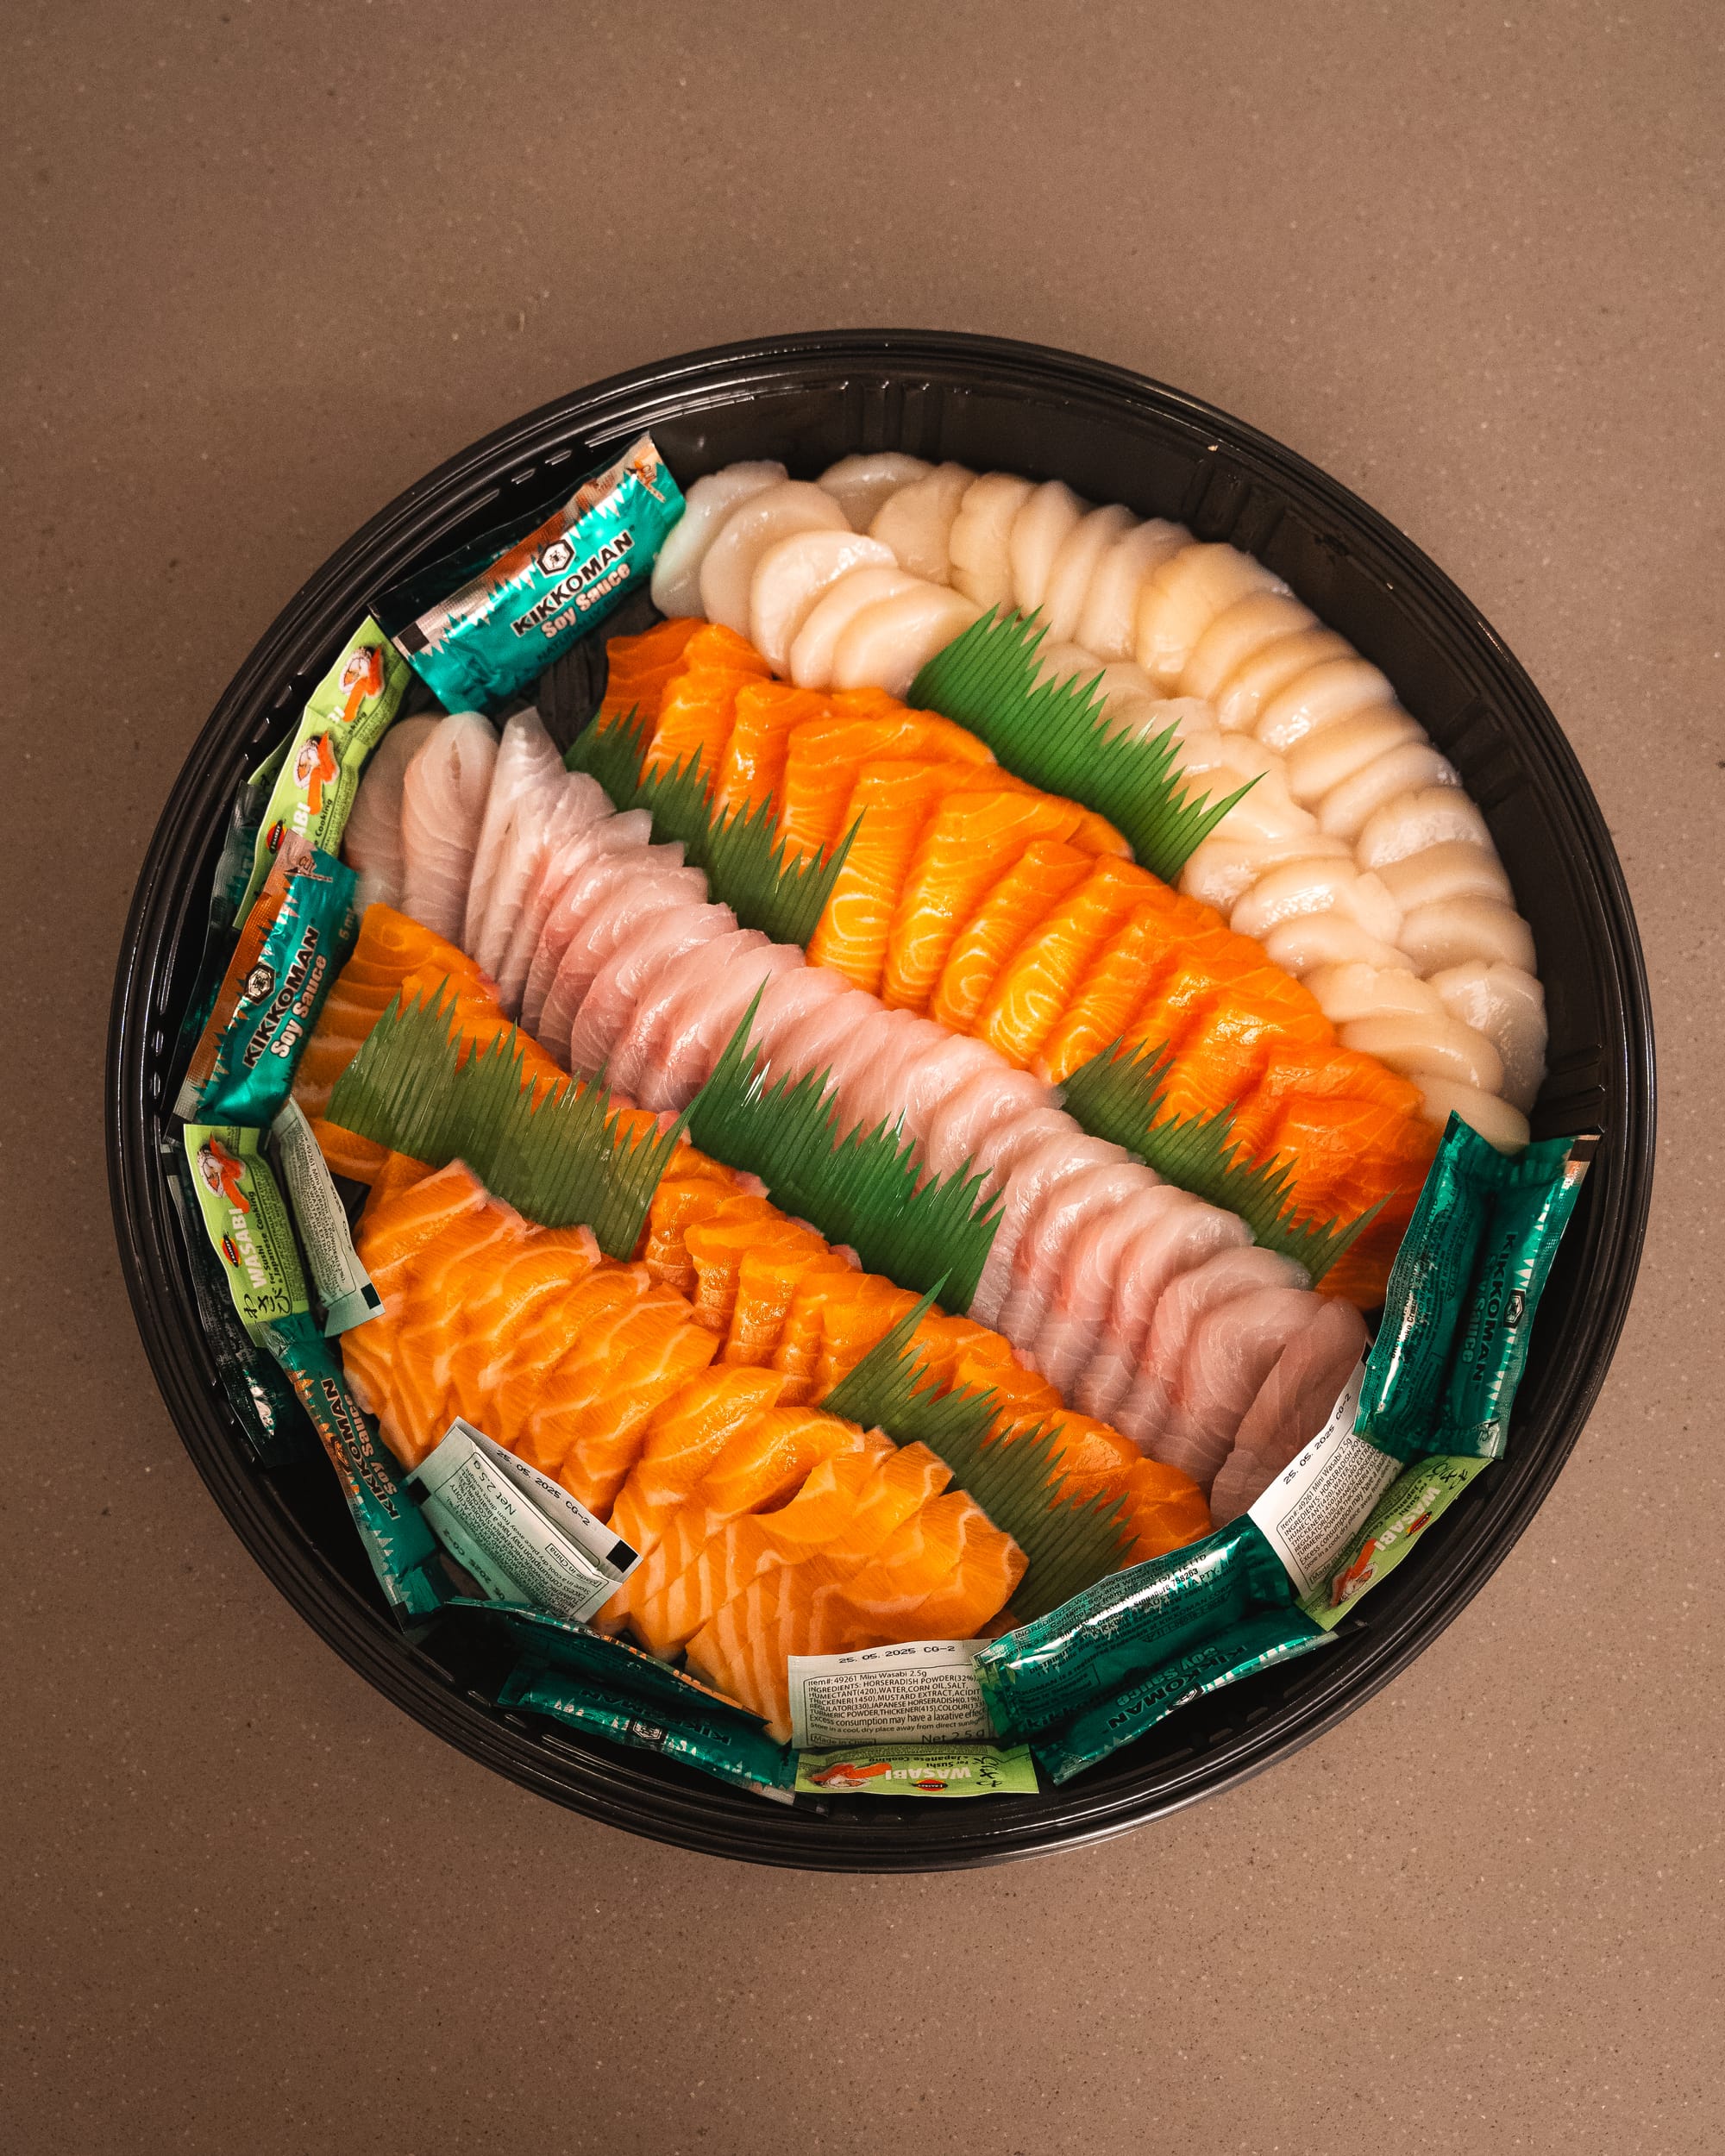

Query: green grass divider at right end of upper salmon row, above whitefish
[1063,1042,1384,1285]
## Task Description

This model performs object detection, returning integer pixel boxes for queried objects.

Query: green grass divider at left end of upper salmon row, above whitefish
[563,711,856,947]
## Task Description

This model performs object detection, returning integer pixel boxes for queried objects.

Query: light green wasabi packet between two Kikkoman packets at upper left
[235,621,412,918]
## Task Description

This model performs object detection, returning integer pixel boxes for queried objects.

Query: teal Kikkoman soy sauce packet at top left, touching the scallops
[378,434,684,711]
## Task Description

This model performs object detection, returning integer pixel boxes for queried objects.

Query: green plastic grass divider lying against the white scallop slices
[908,611,1258,884]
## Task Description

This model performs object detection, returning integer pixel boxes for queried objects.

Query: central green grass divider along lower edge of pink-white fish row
[688,990,1000,1311]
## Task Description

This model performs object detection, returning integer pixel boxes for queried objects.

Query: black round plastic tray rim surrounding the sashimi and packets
[108,330,1654,1871]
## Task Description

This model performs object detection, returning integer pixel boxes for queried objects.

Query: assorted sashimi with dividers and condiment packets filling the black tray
[121,332,1647,1861]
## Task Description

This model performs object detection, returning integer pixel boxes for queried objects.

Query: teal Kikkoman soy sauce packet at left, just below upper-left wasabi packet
[175,835,358,1125]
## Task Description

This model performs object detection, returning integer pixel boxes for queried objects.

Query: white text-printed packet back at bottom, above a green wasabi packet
[787,1639,994,1751]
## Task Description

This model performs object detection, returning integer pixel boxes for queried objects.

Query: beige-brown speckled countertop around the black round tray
[0,0,1725,2156]
